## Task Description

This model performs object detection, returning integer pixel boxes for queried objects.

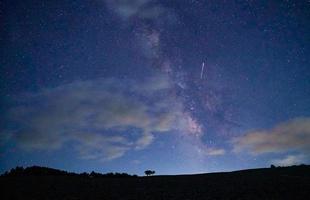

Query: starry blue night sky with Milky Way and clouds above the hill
[0,0,310,175]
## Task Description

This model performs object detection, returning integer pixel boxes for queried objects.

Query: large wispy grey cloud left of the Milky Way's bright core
[0,75,199,160]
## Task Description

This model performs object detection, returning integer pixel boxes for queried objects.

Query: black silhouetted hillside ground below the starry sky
[0,166,310,200]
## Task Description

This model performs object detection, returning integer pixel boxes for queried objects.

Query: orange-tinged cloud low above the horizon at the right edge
[232,117,310,155]
